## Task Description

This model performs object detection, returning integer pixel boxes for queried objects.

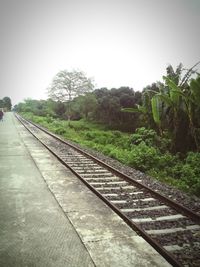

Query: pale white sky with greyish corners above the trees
[0,0,200,107]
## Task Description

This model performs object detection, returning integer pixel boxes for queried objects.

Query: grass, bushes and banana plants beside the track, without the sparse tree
[15,64,200,196]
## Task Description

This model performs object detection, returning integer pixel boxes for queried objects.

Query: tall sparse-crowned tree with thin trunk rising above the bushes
[48,70,94,121]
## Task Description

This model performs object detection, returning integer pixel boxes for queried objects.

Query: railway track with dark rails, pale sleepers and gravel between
[16,115,200,267]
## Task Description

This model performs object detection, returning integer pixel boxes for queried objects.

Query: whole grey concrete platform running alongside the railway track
[0,113,171,267]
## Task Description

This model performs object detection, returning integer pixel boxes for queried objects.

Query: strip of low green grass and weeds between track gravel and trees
[21,113,200,196]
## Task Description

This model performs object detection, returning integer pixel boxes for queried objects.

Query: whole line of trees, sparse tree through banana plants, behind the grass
[15,63,200,154]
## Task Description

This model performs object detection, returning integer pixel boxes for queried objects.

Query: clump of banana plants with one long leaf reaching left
[123,62,200,151]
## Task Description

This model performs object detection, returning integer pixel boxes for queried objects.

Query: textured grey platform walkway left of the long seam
[0,113,95,267]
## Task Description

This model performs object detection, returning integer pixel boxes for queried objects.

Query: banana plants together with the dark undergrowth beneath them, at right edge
[133,64,200,153]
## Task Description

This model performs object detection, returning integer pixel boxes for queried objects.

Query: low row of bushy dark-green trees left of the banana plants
[14,87,142,132]
